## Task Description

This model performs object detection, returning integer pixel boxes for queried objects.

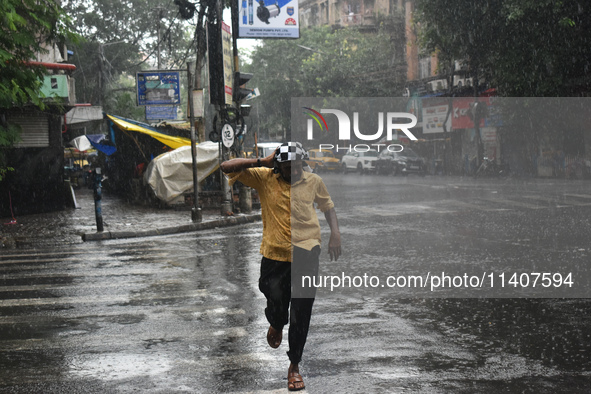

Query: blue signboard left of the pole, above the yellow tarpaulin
[136,71,181,105]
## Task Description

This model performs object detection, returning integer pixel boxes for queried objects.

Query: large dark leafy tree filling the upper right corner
[416,0,591,174]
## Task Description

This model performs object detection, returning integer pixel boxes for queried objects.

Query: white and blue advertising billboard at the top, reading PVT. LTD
[234,0,300,38]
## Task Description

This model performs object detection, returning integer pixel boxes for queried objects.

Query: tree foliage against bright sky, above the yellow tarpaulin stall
[63,0,195,117]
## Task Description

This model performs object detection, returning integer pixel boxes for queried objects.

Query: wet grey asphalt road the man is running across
[0,174,591,393]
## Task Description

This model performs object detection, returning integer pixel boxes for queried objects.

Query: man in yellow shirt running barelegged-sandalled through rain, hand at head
[221,142,341,391]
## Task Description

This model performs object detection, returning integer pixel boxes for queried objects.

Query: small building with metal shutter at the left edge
[0,46,76,217]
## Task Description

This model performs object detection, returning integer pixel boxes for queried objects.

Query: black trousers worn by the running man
[259,247,320,364]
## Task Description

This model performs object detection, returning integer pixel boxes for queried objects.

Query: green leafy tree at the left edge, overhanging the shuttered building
[0,0,76,180]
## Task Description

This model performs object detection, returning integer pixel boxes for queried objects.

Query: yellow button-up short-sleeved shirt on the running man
[229,167,334,261]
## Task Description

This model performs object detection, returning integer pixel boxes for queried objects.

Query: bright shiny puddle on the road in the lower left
[69,353,171,381]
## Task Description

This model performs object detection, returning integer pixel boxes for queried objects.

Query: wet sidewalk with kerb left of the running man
[0,188,261,250]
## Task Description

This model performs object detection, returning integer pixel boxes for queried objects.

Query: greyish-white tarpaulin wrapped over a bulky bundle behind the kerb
[144,141,219,202]
